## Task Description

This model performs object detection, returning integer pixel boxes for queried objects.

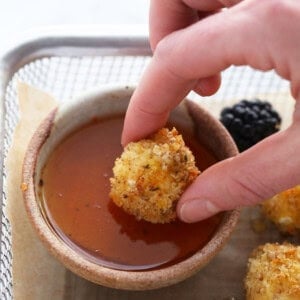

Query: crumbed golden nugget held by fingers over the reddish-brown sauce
[110,128,200,223]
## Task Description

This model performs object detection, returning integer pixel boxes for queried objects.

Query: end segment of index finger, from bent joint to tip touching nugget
[122,57,196,146]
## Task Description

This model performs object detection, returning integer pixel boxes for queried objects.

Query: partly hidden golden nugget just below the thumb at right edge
[262,185,300,234]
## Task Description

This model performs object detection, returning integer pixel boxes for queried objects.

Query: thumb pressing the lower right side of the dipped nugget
[177,123,300,223]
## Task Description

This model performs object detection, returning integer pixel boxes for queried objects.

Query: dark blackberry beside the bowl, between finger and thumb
[220,99,281,152]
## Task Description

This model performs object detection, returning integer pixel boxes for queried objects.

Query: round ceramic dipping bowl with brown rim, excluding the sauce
[22,86,239,290]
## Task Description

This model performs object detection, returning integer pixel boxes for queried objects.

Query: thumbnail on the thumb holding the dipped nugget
[179,199,220,223]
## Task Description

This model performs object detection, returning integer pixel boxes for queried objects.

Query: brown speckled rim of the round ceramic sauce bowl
[22,85,239,290]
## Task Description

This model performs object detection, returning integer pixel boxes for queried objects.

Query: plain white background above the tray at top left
[0,0,150,52]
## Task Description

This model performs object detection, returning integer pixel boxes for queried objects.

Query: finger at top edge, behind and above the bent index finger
[149,0,223,50]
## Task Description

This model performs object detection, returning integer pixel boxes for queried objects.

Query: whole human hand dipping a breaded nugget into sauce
[122,0,300,222]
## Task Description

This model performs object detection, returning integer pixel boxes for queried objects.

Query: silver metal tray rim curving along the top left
[0,25,151,81]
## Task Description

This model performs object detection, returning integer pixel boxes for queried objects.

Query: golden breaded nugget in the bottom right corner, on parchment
[245,243,300,300]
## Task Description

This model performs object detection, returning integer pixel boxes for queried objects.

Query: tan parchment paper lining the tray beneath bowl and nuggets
[6,83,299,300]
